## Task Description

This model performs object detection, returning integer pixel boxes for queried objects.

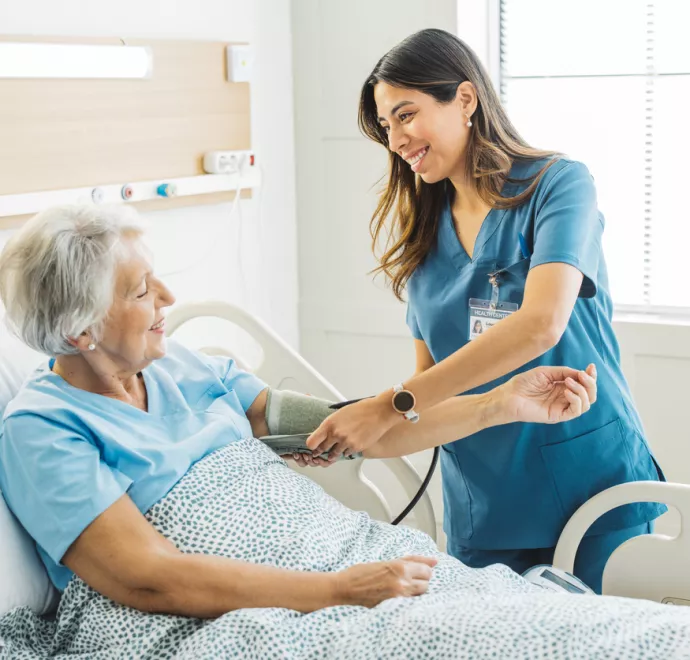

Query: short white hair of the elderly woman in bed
[0,205,143,355]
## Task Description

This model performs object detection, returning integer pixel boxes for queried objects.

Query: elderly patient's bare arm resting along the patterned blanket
[62,495,436,618]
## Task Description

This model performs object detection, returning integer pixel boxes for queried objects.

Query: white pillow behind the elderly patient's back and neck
[0,328,58,616]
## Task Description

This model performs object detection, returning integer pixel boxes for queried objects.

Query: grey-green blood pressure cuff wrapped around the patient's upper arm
[259,389,361,460]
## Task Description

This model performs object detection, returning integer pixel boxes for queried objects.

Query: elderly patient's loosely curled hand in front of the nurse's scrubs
[494,364,597,424]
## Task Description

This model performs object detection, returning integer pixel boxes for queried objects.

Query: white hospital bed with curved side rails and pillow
[0,302,690,616]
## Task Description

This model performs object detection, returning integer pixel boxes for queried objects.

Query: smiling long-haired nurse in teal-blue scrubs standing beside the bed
[308,30,665,591]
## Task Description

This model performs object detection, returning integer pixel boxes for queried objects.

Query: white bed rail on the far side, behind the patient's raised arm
[165,302,437,540]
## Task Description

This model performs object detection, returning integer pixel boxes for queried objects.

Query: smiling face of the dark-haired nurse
[374,82,474,183]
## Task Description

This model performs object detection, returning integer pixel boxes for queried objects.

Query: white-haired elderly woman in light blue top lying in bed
[0,206,632,648]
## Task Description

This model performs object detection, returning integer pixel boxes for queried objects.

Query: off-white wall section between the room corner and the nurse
[292,0,457,540]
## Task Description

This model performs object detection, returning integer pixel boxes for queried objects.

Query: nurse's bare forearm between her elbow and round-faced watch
[390,310,552,414]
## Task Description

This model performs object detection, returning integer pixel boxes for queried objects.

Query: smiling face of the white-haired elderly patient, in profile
[99,238,175,369]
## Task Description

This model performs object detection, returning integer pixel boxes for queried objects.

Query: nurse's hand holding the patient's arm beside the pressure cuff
[307,397,400,461]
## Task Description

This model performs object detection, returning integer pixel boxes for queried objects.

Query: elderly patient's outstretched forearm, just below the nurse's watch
[364,391,506,458]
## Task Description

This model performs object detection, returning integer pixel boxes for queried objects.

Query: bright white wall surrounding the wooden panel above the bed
[0,0,299,346]
